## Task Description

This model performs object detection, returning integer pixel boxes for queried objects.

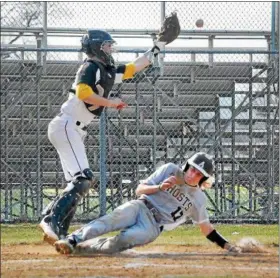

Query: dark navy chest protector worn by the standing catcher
[85,59,116,116]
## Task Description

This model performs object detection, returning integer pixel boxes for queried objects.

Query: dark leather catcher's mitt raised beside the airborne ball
[157,12,181,44]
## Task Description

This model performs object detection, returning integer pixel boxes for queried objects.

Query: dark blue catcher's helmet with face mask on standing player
[81,30,115,65]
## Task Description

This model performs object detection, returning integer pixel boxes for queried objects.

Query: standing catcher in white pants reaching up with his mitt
[39,14,180,244]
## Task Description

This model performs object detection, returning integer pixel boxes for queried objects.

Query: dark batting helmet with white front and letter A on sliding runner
[183,152,214,187]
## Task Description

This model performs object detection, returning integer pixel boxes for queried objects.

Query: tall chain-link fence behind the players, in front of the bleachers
[1,2,279,222]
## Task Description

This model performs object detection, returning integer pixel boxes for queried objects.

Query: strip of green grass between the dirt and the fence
[1,224,279,245]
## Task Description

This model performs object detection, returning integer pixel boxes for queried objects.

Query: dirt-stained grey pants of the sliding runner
[70,200,160,253]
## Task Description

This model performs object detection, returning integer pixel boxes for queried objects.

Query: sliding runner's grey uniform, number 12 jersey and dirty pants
[69,163,209,253]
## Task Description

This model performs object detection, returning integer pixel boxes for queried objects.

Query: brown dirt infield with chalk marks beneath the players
[1,243,278,278]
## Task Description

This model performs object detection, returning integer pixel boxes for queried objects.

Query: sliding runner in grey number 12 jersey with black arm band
[55,153,243,254]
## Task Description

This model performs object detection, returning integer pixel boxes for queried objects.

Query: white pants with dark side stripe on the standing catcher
[48,114,89,181]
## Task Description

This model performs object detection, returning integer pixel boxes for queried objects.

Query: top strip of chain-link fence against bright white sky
[1,1,272,31]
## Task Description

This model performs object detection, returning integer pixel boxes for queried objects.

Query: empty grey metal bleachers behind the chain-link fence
[1,56,279,220]
